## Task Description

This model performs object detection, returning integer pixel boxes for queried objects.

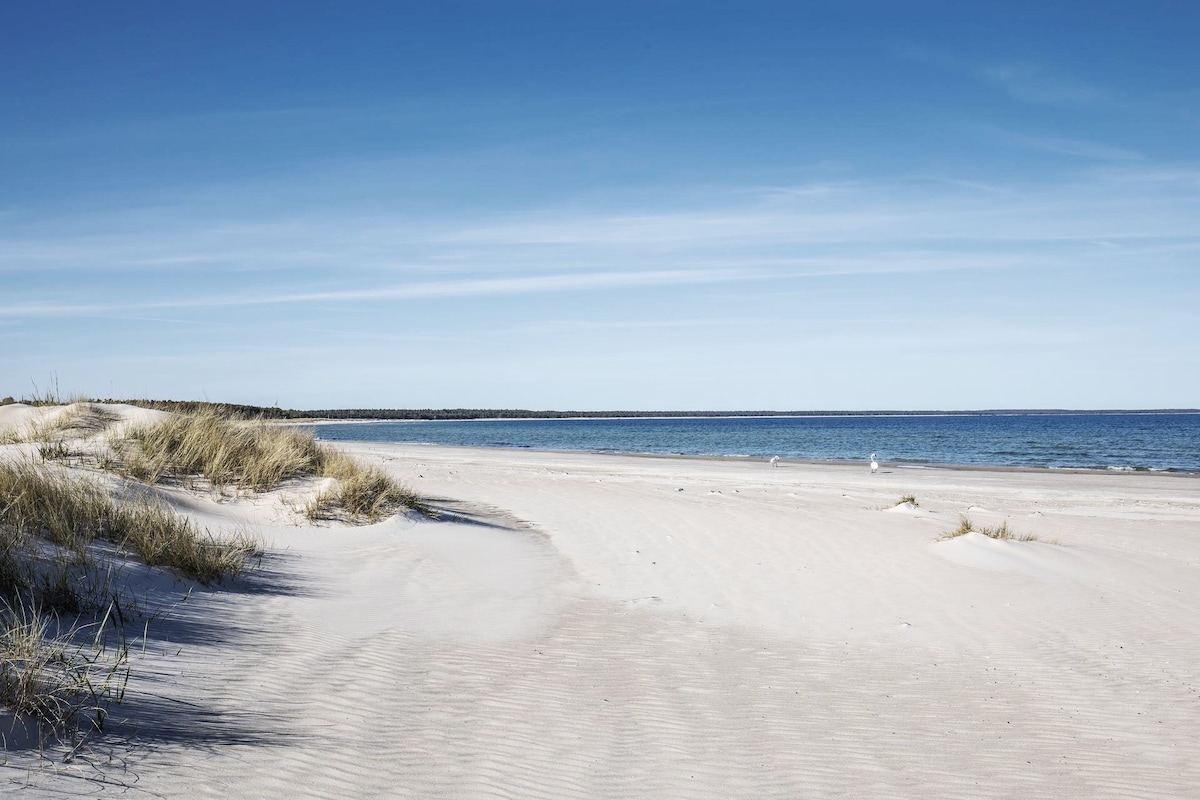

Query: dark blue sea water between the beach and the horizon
[314,414,1200,473]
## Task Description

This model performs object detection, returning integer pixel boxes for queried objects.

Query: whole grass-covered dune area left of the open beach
[0,403,418,745]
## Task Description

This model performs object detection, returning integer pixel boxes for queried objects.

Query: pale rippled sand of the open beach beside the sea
[0,417,1200,800]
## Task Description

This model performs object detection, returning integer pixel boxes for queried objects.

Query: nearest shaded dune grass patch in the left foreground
[0,459,259,741]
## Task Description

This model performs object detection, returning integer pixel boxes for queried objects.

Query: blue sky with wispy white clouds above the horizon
[0,0,1200,410]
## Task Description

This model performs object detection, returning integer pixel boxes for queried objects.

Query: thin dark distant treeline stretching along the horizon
[77,398,1198,420]
